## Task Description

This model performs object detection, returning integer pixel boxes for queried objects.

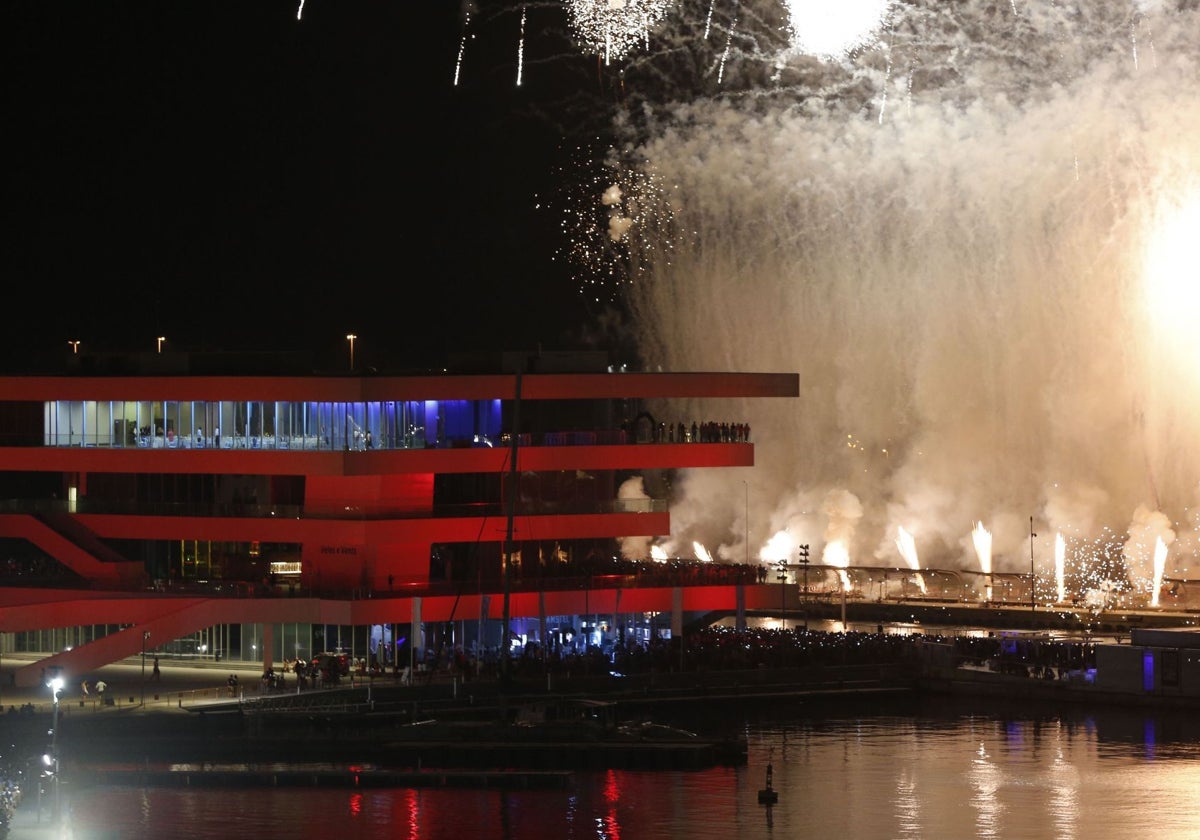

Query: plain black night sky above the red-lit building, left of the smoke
[2,0,609,370]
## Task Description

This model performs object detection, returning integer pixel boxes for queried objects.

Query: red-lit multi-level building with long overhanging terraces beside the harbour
[0,354,799,683]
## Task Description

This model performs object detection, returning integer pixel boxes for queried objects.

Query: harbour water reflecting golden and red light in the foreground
[63,701,1200,840]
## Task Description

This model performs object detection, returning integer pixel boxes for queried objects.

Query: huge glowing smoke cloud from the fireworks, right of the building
[597,0,1200,592]
